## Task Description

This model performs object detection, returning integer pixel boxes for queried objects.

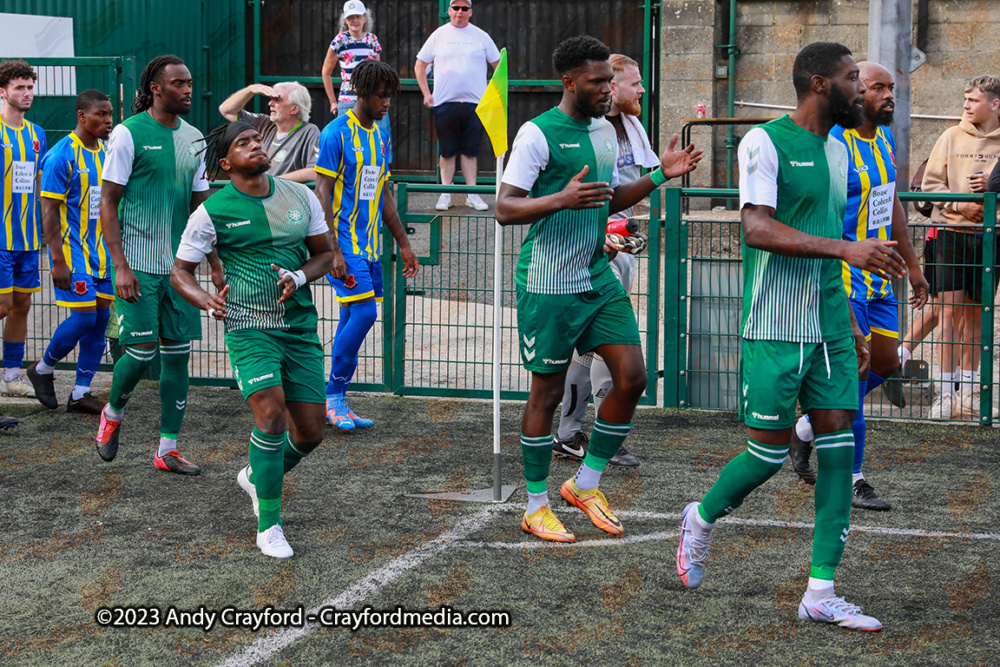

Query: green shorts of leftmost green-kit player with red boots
[115,271,202,345]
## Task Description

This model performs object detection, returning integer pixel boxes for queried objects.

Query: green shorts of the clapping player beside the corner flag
[517,281,640,373]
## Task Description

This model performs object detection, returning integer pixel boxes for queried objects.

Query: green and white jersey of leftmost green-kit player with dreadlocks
[101,112,208,276]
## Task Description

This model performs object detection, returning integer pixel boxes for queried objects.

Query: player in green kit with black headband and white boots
[170,121,333,558]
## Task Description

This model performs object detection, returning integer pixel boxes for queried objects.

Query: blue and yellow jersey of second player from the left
[42,132,109,278]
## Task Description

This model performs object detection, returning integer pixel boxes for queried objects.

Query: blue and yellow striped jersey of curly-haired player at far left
[0,120,46,251]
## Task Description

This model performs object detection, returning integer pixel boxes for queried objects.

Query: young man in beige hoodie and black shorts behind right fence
[921,75,1000,419]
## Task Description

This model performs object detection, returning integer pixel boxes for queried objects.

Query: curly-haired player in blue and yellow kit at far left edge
[0,60,46,412]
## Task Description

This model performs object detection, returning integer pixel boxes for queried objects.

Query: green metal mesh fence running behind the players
[9,183,1000,424]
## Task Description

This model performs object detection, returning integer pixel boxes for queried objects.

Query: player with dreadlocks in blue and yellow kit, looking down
[316,60,418,431]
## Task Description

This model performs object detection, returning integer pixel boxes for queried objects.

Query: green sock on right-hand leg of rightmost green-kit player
[809,429,854,581]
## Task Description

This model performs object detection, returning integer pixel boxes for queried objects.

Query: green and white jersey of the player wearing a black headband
[177,176,329,332]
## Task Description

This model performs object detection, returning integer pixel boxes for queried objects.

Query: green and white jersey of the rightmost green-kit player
[739,115,851,343]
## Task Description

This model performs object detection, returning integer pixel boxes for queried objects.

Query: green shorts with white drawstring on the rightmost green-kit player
[740,336,858,430]
